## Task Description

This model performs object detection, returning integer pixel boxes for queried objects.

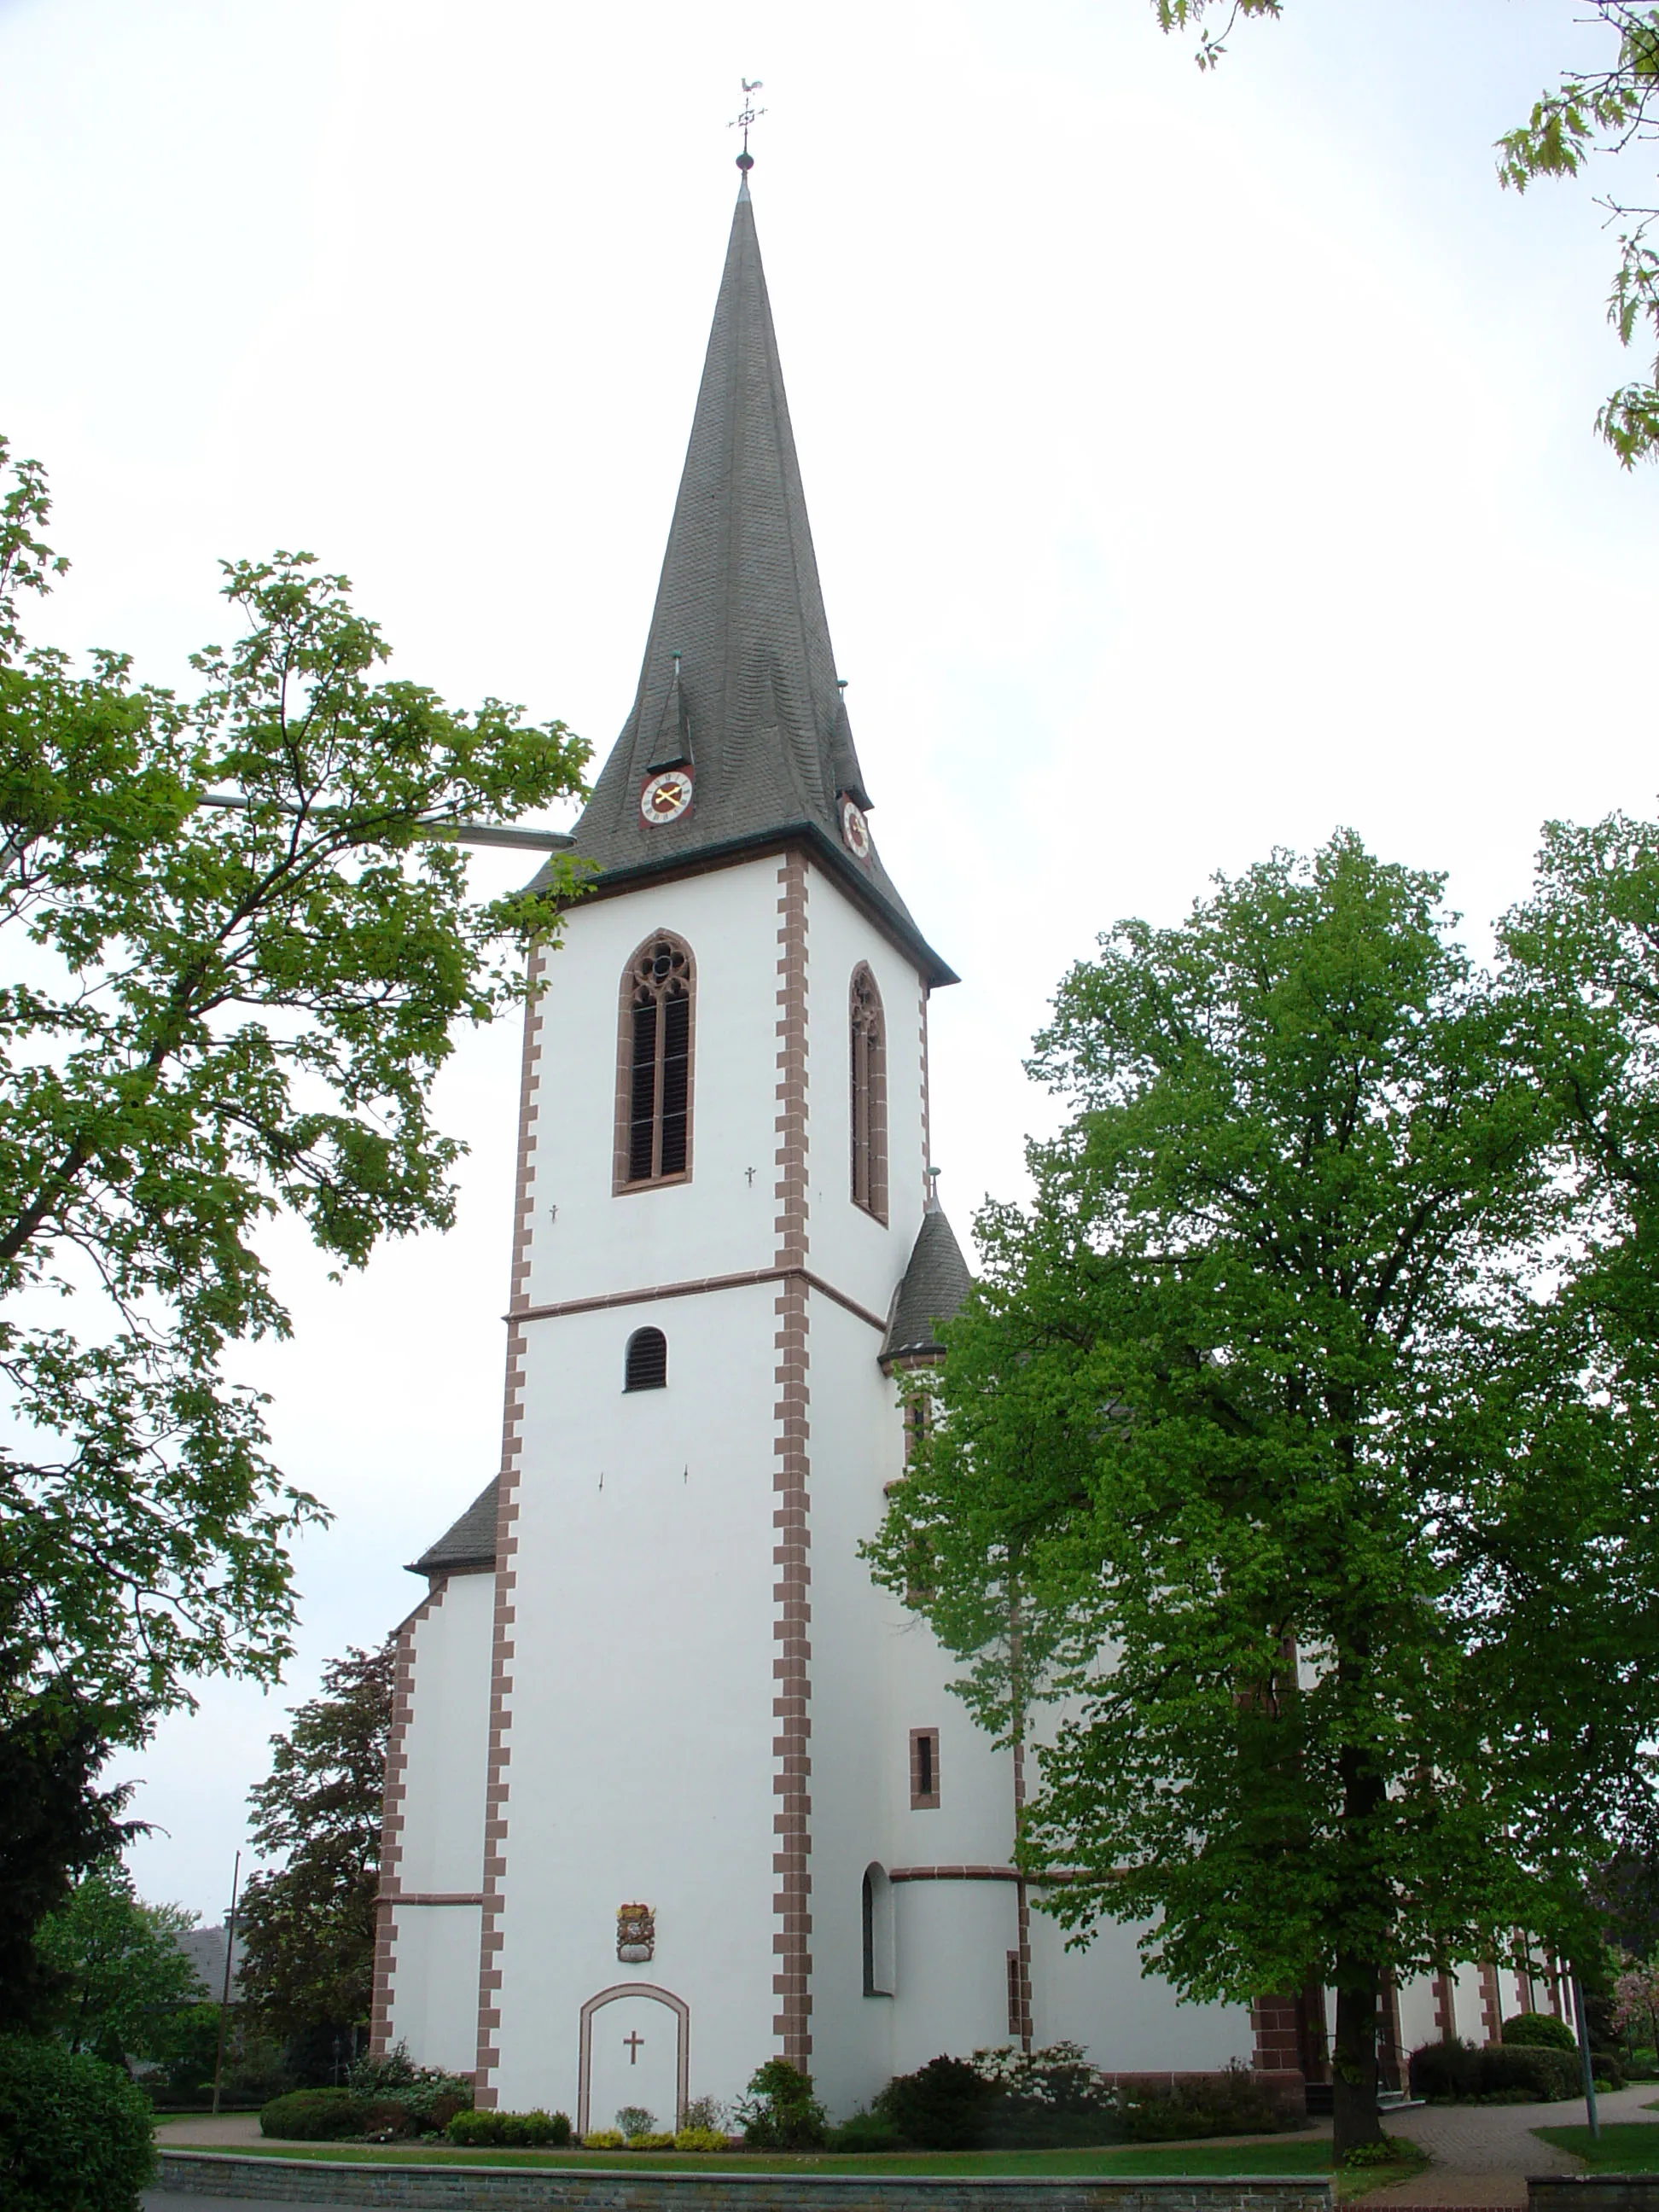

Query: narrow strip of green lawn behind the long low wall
[164,2128,1336,2187]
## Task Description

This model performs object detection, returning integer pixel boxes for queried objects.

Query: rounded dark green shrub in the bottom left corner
[0,2035,154,2212]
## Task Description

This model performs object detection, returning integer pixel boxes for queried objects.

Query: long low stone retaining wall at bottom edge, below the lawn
[154,2150,1336,2212]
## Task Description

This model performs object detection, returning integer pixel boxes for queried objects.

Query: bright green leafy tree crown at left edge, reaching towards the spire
[0,445,586,1734]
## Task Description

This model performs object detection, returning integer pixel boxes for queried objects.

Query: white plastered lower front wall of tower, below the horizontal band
[496,1285,777,2123]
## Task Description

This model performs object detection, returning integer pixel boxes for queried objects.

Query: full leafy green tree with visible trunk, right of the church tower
[871,834,1659,2150]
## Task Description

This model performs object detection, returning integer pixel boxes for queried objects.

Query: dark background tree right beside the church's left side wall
[239,1644,393,2037]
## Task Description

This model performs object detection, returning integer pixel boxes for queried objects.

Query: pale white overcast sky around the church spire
[0,0,1659,1918]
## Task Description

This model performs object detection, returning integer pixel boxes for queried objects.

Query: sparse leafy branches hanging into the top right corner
[1152,0,1659,469]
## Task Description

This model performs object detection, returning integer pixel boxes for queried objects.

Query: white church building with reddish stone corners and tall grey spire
[376,179,1566,2130]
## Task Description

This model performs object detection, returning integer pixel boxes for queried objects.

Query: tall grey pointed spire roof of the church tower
[553,177,956,982]
